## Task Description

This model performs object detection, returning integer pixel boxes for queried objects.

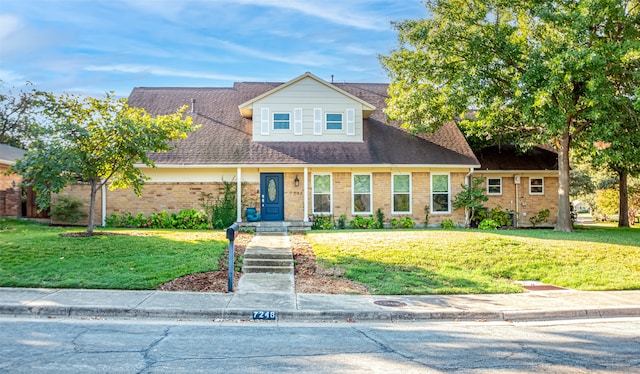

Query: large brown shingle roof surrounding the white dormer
[129,82,479,166]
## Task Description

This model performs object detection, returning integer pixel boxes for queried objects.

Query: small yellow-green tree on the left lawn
[12,93,196,233]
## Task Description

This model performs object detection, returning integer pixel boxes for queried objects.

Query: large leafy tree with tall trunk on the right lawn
[381,0,640,231]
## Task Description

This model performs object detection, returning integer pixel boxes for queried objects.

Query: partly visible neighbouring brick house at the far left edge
[0,144,24,217]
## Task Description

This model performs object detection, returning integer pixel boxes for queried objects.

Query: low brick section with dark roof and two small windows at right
[473,145,558,227]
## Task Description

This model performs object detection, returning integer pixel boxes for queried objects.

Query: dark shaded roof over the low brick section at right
[476,145,558,170]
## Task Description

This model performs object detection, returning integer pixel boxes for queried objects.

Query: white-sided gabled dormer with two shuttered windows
[238,72,376,142]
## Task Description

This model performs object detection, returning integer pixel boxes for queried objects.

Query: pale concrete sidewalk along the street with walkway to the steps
[0,235,640,322]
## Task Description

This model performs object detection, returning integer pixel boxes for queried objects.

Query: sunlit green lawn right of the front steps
[307,227,640,294]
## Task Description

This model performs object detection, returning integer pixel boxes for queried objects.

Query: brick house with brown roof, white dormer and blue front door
[57,73,557,225]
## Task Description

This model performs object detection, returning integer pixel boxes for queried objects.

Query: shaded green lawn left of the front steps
[0,220,228,289]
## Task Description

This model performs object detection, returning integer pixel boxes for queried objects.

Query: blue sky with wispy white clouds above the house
[0,0,426,96]
